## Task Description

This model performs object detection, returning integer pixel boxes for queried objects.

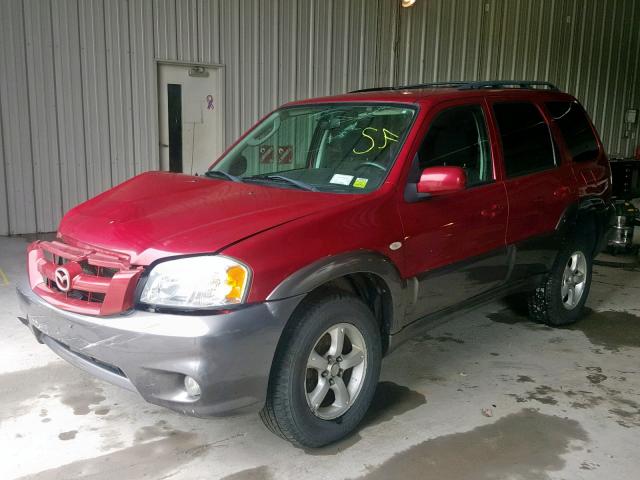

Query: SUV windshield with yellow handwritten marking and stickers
[210,103,415,193]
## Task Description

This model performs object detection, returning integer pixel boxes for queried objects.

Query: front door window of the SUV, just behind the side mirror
[418,105,493,186]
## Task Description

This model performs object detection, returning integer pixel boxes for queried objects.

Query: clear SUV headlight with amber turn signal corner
[140,255,249,308]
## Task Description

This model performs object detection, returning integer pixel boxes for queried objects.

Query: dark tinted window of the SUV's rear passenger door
[493,103,556,177]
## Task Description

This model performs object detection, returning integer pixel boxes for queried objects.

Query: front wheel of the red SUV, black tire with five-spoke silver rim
[260,292,382,448]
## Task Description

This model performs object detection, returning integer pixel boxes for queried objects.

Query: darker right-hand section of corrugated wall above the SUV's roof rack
[397,0,640,156]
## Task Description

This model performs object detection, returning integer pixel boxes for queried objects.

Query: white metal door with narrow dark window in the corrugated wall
[158,64,224,173]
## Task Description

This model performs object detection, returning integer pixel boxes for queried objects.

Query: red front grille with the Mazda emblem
[29,241,141,315]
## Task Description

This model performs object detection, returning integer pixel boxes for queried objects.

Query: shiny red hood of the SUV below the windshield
[59,172,354,265]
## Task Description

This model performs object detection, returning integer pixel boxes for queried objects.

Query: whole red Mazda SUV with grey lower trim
[18,82,611,447]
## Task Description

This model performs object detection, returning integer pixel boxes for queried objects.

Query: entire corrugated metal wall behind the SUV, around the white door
[0,0,640,234]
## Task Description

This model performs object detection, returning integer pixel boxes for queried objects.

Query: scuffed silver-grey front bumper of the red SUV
[17,281,301,416]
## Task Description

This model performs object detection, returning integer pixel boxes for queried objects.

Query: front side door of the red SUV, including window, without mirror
[399,101,508,321]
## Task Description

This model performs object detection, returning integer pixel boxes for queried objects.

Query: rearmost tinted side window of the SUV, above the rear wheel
[545,102,598,162]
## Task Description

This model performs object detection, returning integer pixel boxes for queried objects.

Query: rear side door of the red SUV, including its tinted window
[492,101,576,279]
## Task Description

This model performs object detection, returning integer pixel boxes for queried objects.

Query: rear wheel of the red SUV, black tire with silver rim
[528,238,593,327]
